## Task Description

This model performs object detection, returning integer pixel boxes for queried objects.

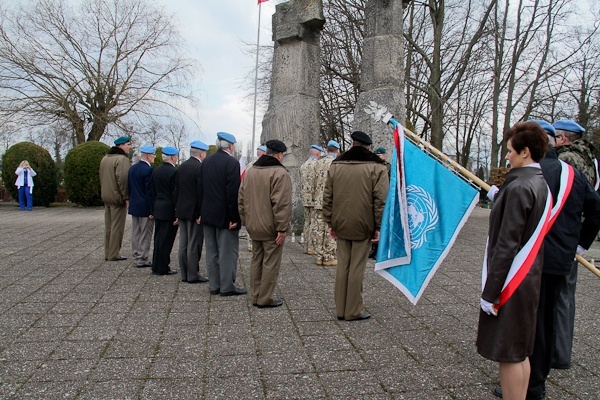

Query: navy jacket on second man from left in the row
[127,161,154,217]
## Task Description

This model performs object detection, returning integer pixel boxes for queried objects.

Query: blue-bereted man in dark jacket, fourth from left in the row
[175,140,208,283]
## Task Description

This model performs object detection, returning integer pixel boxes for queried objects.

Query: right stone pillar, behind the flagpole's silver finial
[354,0,407,154]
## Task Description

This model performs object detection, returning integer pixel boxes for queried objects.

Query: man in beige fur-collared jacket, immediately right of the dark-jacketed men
[238,140,292,308]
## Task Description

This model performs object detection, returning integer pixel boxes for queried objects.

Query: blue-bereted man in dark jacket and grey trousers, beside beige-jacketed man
[200,132,246,296]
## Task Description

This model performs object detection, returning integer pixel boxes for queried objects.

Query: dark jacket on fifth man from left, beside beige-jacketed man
[200,150,241,229]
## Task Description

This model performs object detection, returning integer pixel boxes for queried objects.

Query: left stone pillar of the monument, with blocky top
[261,0,325,230]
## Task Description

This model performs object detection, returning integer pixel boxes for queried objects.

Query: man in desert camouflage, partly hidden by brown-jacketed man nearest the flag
[311,140,340,267]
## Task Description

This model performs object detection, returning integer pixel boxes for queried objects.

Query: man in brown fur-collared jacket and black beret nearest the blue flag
[323,131,389,321]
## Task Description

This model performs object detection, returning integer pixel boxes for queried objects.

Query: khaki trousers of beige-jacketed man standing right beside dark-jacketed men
[250,240,283,306]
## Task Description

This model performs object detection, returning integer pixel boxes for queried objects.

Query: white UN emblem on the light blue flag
[406,185,439,249]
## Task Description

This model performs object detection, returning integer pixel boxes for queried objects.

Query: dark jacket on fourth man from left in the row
[175,157,202,221]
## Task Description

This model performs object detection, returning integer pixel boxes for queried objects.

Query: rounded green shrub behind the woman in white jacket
[2,142,57,206]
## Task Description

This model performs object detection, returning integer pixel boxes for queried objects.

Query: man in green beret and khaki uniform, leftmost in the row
[100,136,131,261]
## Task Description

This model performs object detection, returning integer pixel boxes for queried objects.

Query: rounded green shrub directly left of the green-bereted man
[64,141,110,207]
